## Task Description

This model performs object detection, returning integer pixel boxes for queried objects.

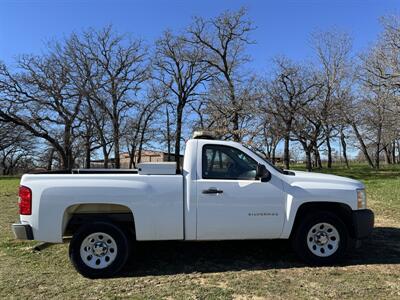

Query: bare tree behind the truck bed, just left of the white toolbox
[71,26,148,168]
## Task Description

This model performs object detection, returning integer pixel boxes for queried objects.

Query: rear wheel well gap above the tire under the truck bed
[63,203,136,239]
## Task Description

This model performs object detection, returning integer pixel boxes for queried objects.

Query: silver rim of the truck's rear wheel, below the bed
[80,232,118,269]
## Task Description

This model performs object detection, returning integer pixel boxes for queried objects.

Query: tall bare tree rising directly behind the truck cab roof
[188,9,254,141]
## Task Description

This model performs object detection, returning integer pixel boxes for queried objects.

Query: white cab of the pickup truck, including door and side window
[183,139,286,240]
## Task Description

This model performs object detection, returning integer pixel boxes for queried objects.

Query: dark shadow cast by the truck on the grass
[119,227,400,277]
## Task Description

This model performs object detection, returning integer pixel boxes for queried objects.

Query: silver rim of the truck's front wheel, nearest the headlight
[307,223,340,257]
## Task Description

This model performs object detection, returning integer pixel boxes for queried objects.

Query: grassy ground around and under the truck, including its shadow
[0,165,400,299]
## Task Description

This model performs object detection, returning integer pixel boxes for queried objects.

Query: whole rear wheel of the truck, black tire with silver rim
[69,222,130,278]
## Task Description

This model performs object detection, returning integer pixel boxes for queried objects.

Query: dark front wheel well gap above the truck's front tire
[291,202,354,237]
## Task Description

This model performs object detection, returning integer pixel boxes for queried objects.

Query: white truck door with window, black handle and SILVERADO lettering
[197,144,284,240]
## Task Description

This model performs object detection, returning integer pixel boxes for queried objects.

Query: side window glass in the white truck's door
[202,145,257,180]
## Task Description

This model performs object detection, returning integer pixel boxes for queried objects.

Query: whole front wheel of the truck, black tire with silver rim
[291,211,349,266]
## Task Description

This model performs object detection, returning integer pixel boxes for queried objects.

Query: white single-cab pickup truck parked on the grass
[12,138,374,278]
